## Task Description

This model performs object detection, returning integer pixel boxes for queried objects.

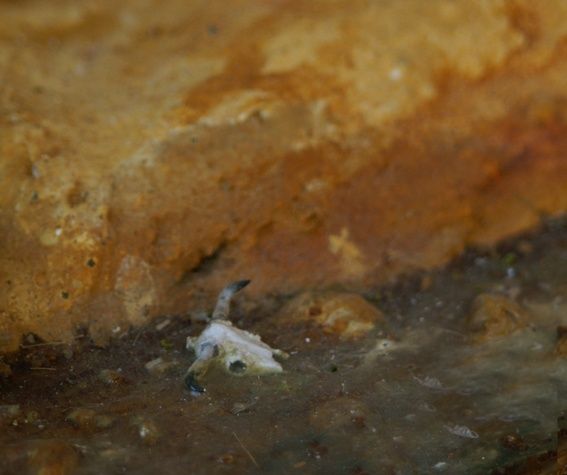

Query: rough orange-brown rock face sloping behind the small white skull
[0,0,567,350]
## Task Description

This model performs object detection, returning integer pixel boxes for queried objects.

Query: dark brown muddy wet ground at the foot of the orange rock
[0,220,567,474]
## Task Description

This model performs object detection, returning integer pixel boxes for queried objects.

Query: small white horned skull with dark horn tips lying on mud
[185,280,288,393]
